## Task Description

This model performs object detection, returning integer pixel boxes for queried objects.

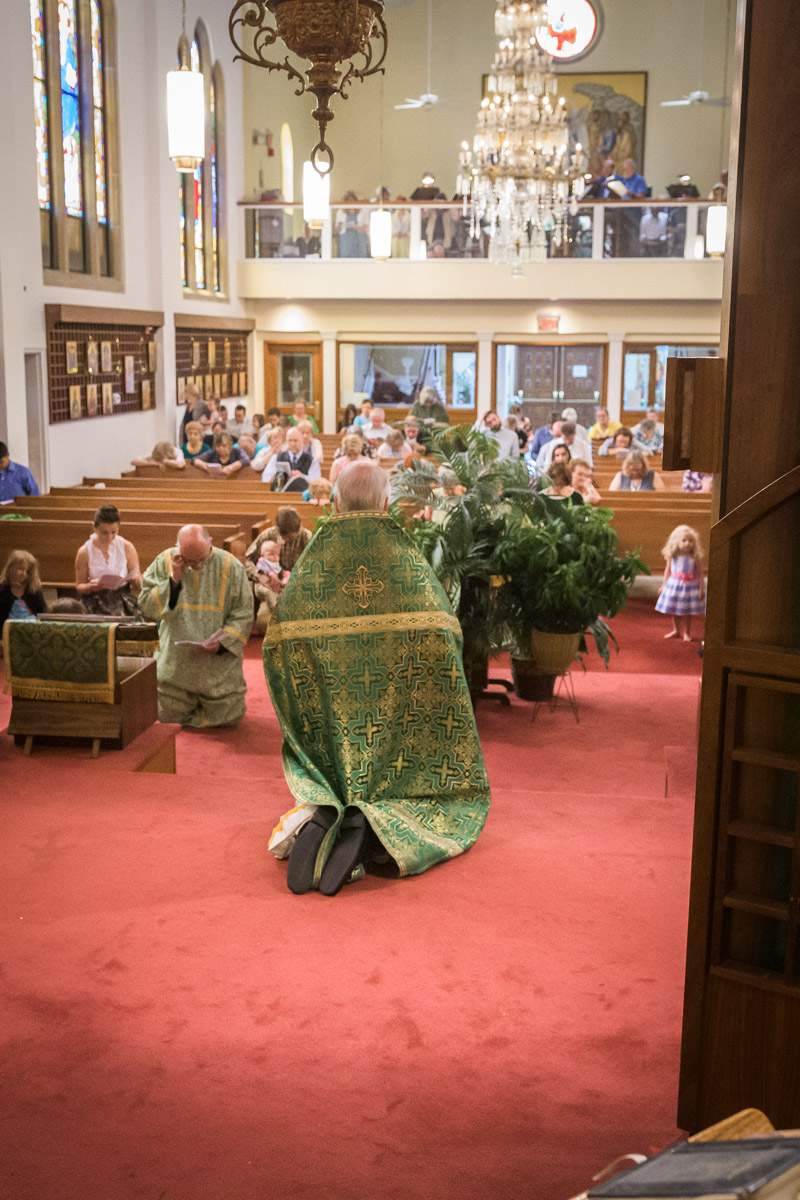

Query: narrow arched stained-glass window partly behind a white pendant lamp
[179,20,225,296]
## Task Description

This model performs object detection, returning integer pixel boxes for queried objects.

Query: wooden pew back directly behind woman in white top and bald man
[0,520,247,588]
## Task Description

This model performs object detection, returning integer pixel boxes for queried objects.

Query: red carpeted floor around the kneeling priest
[0,601,699,1200]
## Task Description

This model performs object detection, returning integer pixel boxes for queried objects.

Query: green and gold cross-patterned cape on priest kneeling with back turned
[264,512,489,875]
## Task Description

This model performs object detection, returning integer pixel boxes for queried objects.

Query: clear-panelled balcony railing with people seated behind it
[240,200,724,262]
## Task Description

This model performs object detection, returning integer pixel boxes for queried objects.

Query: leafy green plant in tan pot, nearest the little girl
[497,504,648,698]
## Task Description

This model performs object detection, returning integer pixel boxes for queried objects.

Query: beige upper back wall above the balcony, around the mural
[243,0,735,199]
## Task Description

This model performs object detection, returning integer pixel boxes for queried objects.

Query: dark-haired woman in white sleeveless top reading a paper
[76,504,142,617]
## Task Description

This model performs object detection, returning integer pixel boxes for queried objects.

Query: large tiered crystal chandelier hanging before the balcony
[458,0,583,271]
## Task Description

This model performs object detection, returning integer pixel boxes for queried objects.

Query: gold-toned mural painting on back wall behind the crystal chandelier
[558,71,648,175]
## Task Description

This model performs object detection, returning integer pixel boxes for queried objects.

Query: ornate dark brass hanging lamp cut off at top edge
[228,0,389,175]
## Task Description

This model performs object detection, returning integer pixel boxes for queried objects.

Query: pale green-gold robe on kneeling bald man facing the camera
[139,548,253,726]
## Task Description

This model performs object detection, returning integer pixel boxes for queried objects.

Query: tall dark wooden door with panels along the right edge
[678,0,800,1130]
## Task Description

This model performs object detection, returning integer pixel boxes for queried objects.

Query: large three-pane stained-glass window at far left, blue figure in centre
[29,0,121,287]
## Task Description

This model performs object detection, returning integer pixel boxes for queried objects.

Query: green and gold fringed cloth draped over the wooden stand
[2,620,119,704]
